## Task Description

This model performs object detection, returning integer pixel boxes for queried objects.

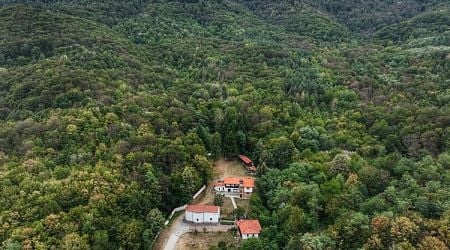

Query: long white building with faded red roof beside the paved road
[184,205,220,223]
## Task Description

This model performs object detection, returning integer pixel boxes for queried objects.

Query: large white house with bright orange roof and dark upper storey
[214,177,255,199]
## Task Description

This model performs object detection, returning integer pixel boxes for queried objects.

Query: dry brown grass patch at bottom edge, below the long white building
[176,232,238,250]
